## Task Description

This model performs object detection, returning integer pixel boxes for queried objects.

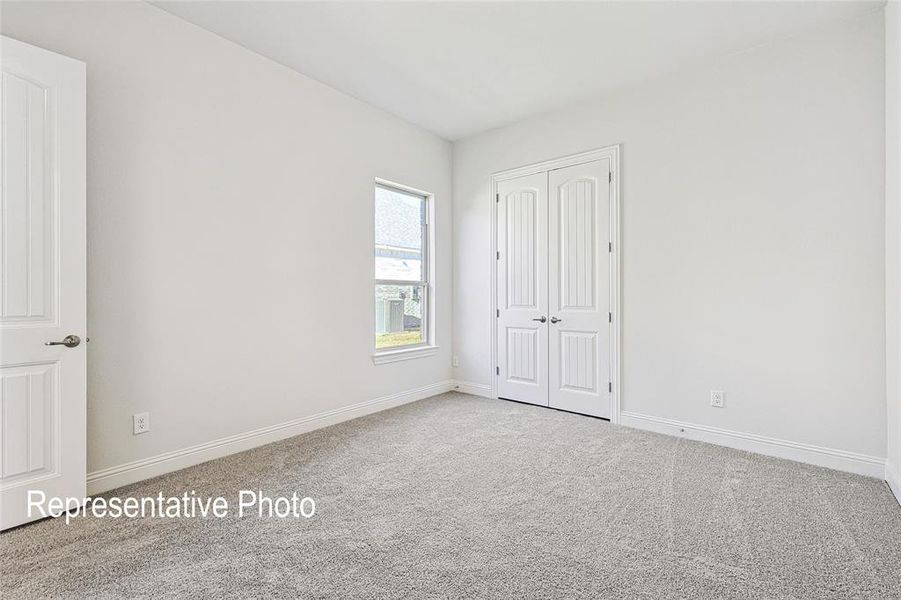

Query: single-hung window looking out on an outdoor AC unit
[375,181,433,362]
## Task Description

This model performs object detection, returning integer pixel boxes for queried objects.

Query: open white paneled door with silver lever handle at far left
[0,36,86,529]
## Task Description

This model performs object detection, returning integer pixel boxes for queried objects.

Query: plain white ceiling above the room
[154,1,882,140]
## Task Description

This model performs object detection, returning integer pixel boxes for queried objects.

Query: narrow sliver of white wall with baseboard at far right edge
[885,1,901,500]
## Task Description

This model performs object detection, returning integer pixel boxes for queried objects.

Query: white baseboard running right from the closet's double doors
[620,411,886,479]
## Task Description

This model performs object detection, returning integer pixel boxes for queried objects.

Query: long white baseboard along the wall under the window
[88,380,455,495]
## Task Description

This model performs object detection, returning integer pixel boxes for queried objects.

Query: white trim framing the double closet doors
[488,144,622,423]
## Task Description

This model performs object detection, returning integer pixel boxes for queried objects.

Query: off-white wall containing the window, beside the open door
[0,2,452,478]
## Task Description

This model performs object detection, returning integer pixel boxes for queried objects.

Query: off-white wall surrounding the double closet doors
[454,10,886,457]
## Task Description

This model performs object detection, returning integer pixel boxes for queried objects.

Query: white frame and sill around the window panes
[370,178,438,365]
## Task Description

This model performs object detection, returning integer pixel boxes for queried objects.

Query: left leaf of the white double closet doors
[496,173,548,406]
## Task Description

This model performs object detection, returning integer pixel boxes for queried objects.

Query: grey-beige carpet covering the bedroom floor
[0,393,901,600]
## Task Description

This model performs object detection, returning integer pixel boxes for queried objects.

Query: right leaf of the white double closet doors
[548,159,612,418]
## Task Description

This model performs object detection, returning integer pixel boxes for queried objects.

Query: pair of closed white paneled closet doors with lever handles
[496,159,612,418]
